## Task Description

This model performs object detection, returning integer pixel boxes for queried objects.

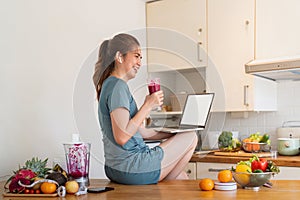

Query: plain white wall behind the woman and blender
[0,0,146,179]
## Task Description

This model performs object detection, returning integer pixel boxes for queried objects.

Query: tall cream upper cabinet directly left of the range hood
[206,0,277,111]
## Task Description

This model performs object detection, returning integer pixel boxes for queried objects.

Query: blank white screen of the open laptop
[180,93,214,127]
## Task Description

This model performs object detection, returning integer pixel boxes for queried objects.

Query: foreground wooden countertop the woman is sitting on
[0,179,300,200]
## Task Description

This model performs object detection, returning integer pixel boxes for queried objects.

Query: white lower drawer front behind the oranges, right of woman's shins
[196,162,233,180]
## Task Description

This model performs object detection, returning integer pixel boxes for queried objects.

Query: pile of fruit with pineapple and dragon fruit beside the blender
[5,158,79,194]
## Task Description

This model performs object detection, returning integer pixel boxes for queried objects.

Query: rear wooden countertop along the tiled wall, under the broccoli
[190,152,300,167]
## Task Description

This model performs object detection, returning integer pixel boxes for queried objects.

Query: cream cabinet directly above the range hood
[256,0,300,59]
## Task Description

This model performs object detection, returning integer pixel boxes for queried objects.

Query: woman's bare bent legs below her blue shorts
[159,131,198,181]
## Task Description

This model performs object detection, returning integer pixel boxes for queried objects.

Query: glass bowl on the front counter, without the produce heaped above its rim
[232,172,275,190]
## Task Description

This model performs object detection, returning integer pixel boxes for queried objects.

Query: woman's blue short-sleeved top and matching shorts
[98,76,163,184]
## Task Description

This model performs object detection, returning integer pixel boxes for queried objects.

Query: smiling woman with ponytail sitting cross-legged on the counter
[93,34,197,184]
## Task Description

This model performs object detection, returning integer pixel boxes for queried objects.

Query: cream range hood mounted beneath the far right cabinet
[245,55,300,81]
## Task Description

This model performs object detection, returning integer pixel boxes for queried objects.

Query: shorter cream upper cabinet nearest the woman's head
[146,0,207,72]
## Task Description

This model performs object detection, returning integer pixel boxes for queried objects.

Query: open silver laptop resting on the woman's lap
[154,93,214,133]
